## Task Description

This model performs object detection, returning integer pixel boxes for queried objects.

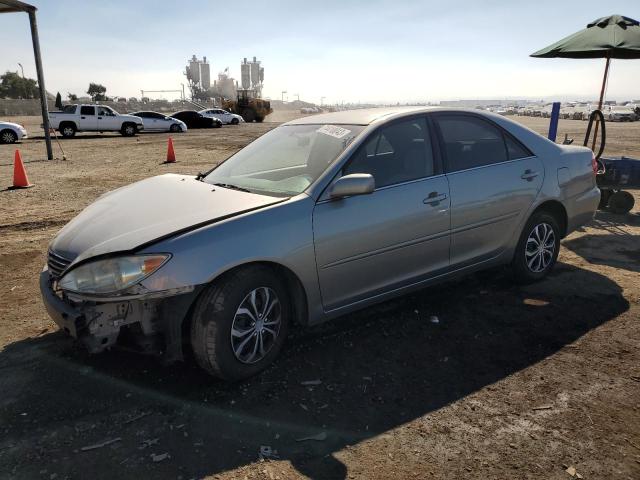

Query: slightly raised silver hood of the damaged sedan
[50,174,282,263]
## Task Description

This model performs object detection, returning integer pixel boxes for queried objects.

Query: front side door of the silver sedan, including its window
[313,116,449,311]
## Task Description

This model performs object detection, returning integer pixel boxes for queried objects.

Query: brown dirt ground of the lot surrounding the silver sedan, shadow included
[0,112,640,480]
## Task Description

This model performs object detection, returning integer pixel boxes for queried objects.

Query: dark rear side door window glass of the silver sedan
[436,114,508,172]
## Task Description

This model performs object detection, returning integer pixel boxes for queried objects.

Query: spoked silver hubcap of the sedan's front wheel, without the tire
[231,287,282,364]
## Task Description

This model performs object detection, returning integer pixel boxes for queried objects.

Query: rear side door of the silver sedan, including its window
[434,113,544,268]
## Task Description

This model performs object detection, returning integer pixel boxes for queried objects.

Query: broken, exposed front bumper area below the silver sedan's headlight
[40,268,200,361]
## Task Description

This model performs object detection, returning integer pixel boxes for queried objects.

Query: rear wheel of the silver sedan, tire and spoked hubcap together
[511,211,560,284]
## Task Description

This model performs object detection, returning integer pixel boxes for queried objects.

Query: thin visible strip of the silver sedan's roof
[285,107,485,125]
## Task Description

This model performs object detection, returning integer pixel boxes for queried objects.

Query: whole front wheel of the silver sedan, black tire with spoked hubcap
[191,266,292,381]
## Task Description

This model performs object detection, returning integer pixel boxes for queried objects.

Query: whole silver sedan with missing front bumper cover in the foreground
[40,107,600,380]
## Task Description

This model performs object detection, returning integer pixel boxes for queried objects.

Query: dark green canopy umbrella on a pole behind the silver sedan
[531,15,640,109]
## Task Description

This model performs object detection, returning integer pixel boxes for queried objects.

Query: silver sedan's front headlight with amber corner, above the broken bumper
[58,254,171,295]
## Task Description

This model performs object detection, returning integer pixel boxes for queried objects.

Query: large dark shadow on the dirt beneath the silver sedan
[0,256,628,479]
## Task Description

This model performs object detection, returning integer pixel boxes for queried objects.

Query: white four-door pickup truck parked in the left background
[49,105,144,138]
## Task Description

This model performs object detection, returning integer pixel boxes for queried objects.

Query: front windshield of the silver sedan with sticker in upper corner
[204,125,364,196]
